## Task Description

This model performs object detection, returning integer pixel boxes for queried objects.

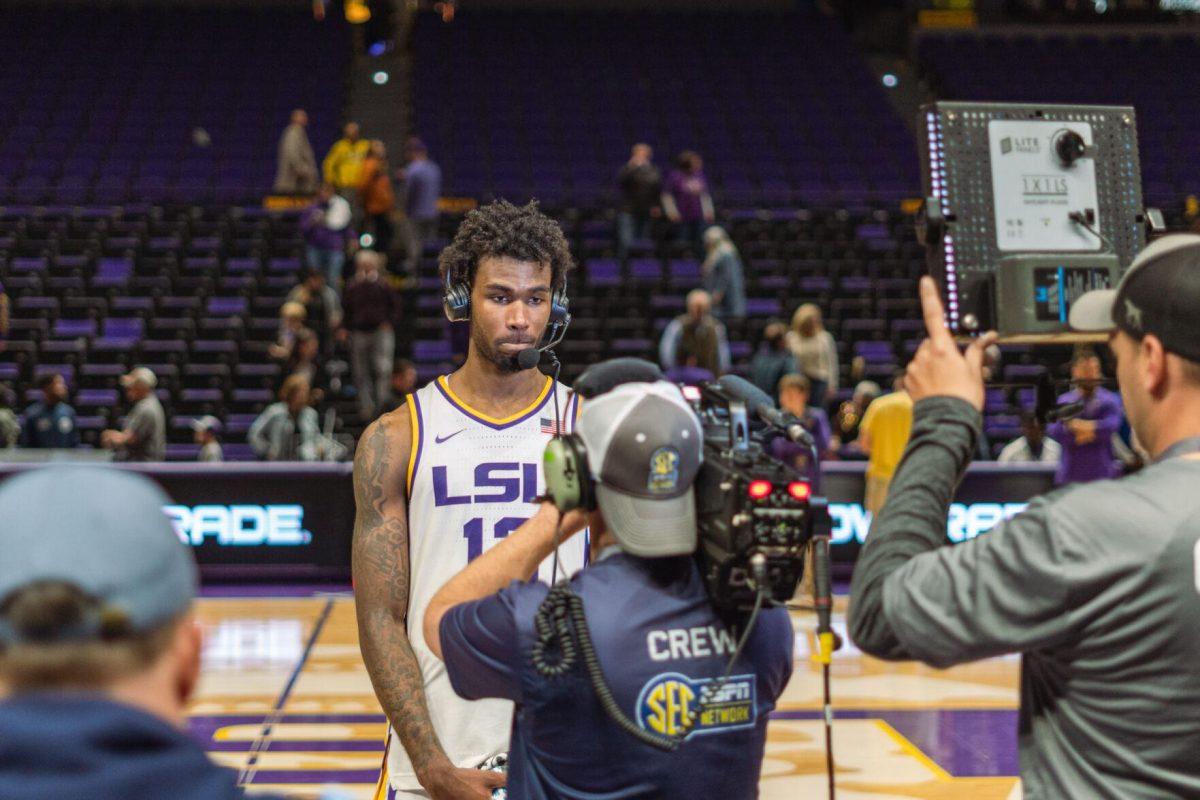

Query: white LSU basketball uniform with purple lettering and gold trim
[379,375,588,792]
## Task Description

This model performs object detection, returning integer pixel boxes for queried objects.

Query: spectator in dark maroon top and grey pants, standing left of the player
[343,249,401,420]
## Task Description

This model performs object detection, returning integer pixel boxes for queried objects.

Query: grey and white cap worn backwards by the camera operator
[576,380,704,558]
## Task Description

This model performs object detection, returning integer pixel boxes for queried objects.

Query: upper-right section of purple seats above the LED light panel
[918,31,1200,205]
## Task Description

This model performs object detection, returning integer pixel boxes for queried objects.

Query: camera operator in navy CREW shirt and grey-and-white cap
[425,381,793,799]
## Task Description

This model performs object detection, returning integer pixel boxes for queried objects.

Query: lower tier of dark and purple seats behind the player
[0,197,1060,458]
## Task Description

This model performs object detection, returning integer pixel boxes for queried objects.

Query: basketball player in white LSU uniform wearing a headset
[353,201,587,800]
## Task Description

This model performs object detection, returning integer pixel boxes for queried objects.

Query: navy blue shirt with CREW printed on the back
[440,552,793,800]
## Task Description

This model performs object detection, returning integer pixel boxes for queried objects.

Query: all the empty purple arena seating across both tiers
[0,8,1152,458]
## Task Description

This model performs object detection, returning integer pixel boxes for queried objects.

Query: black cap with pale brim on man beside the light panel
[1070,234,1200,361]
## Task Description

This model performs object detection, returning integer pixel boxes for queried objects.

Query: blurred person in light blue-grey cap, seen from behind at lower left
[0,467,285,800]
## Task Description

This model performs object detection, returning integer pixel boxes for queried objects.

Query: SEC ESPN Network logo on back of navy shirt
[637,672,758,736]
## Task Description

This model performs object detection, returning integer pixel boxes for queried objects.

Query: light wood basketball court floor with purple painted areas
[191,588,1020,800]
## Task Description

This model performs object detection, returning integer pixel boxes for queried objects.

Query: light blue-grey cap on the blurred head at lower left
[0,467,197,644]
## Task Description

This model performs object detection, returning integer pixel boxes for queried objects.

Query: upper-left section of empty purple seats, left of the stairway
[0,4,349,205]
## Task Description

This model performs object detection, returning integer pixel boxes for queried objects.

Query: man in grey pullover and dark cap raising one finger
[850,235,1200,800]
